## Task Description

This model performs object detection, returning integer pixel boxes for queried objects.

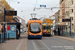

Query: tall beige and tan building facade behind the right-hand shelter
[60,0,75,37]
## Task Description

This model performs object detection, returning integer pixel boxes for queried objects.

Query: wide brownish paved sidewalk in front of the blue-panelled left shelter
[0,34,27,50]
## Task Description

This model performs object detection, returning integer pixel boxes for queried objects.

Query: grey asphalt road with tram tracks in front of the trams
[28,37,75,50]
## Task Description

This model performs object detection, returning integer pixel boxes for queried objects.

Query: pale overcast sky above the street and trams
[6,0,59,23]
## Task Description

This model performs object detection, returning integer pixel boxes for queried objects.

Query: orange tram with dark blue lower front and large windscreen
[28,18,42,39]
